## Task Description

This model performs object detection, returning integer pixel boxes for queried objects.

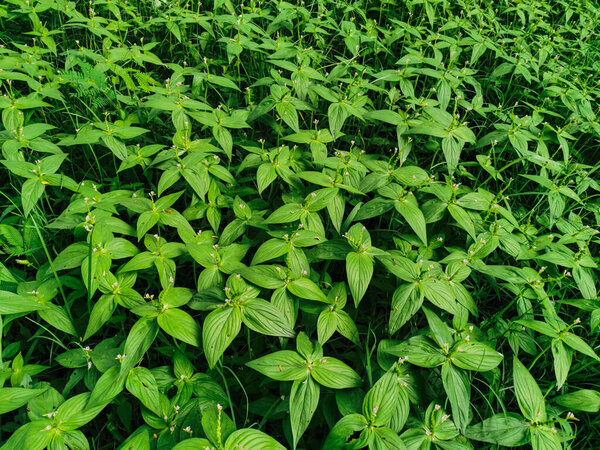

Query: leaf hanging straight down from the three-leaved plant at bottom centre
[290,376,321,448]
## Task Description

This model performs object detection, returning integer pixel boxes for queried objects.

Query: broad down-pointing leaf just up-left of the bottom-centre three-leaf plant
[202,306,242,369]
